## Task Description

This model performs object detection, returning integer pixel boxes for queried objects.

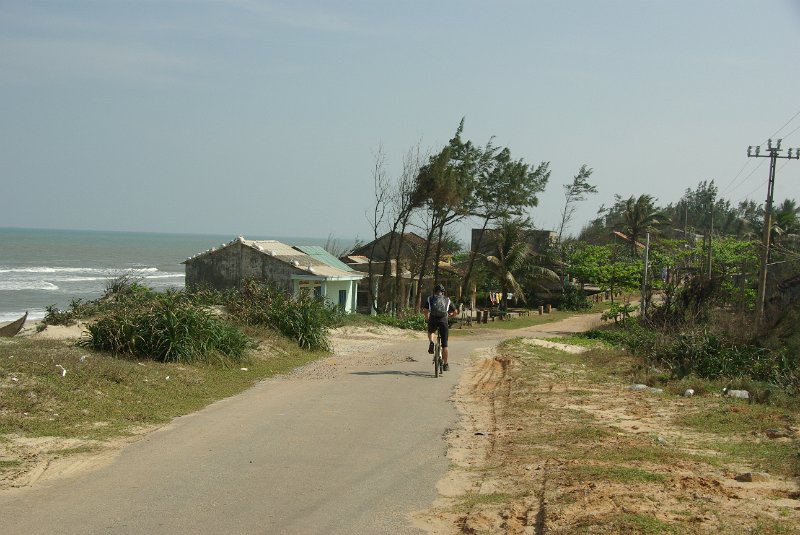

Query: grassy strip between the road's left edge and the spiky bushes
[0,328,324,440]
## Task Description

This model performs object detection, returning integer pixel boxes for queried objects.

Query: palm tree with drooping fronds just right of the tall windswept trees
[486,219,558,309]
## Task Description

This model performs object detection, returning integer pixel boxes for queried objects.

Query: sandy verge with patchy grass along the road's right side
[444,338,800,534]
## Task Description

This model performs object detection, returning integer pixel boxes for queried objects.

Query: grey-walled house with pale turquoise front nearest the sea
[183,236,364,312]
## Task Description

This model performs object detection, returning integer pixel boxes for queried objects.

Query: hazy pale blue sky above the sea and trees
[0,0,800,245]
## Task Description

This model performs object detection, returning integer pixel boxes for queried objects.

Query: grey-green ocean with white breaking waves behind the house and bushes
[0,228,350,323]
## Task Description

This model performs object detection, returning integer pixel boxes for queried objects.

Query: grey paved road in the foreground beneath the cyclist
[0,339,504,535]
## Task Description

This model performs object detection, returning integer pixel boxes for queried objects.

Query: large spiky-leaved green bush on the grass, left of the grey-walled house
[78,292,250,362]
